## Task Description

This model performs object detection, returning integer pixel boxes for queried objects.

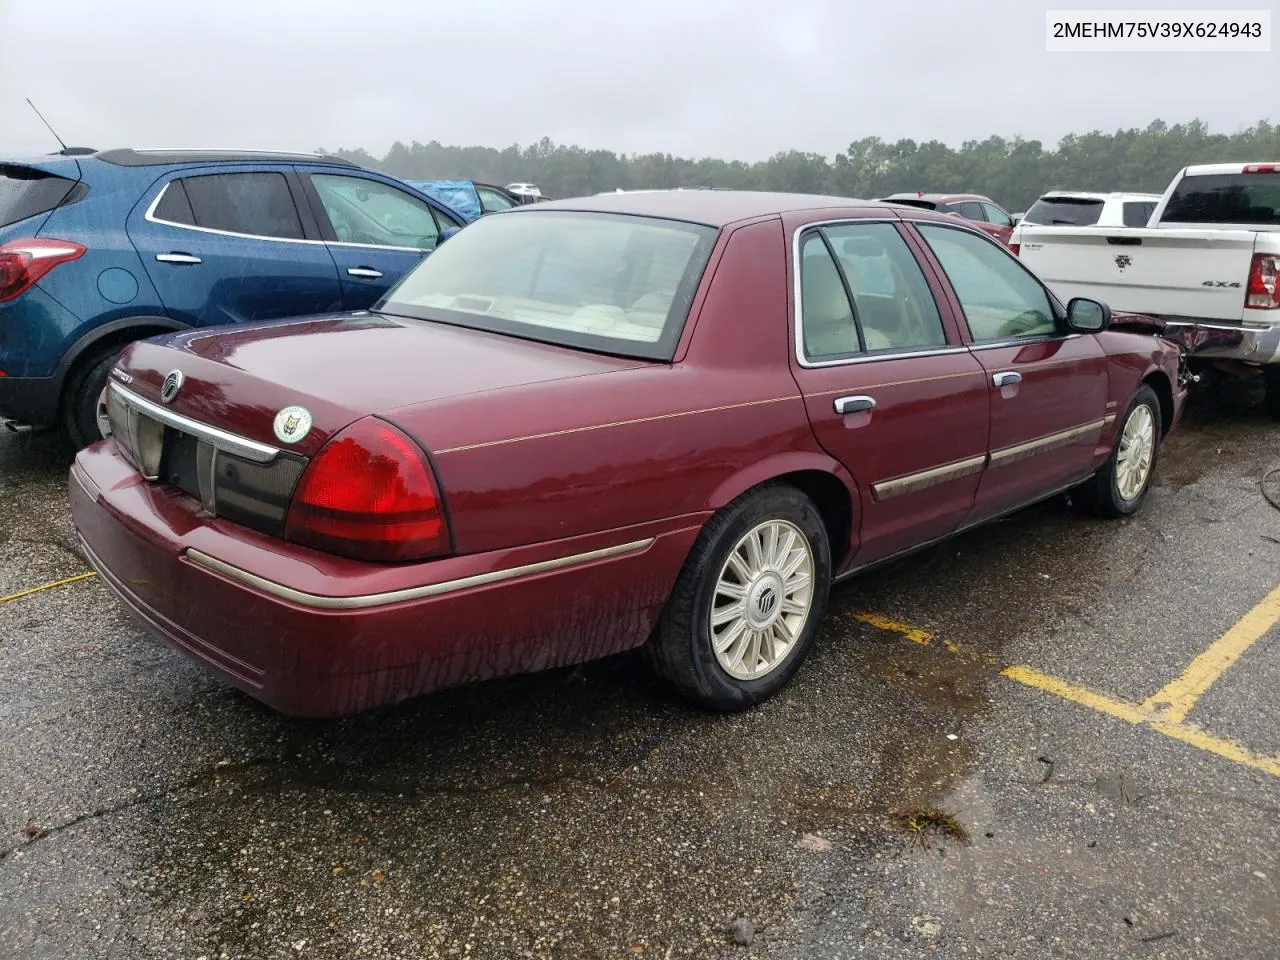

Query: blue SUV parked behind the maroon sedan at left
[0,148,474,447]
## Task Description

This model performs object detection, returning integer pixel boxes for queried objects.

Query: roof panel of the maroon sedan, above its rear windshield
[514,189,920,227]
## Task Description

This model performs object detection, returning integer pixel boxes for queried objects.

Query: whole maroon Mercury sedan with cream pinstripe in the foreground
[70,191,1185,716]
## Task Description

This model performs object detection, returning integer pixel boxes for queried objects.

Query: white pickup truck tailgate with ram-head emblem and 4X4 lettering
[1020,227,1258,324]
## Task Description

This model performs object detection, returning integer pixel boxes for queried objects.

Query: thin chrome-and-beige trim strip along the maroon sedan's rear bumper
[186,536,657,611]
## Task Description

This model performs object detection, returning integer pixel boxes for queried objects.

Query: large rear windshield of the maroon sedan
[375,210,717,360]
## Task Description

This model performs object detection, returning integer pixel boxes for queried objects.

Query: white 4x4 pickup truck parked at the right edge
[1018,163,1280,417]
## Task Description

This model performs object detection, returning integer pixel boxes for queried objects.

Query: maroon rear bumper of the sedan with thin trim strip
[69,440,700,717]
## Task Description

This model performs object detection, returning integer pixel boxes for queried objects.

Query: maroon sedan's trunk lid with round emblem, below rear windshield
[113,312,643,456]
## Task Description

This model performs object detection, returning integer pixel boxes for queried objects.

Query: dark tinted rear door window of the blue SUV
[152,173,303,239]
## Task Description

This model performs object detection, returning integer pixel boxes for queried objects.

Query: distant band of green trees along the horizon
[325,120,1280,211]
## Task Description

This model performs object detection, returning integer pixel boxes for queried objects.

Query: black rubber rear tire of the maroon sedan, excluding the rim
[645,484,831,712]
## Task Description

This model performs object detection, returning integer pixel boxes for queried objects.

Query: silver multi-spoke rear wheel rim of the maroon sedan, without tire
[709,520,814,680]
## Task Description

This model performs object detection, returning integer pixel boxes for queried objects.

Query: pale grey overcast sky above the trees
[0,0,1280,160]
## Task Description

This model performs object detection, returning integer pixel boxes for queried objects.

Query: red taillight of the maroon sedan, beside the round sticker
[284,417,449,563]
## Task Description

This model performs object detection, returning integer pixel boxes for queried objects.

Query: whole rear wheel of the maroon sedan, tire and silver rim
[646,485,831,712]
